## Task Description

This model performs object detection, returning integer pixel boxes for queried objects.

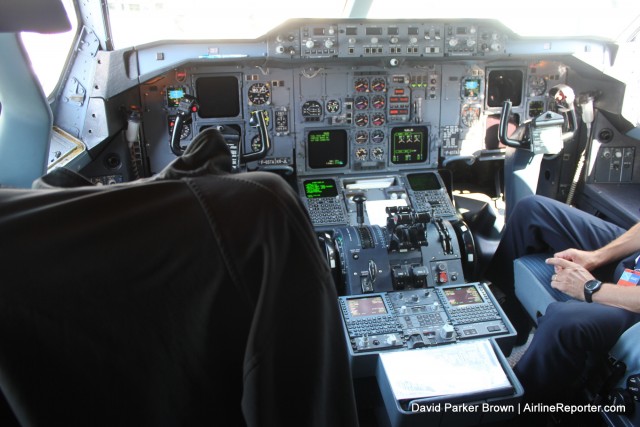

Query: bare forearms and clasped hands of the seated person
[547,223,640,313]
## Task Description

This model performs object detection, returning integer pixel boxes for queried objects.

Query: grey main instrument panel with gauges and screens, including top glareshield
[139,20,567,179]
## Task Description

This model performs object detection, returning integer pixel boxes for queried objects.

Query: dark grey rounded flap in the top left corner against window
[0,0,71,34]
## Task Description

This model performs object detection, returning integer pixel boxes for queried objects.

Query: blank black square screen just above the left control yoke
[196,76,240,119]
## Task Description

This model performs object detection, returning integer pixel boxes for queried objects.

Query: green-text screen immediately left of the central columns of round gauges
[307,129,348,169]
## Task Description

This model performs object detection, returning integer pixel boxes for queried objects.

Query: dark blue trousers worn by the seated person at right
[485,196,640,402]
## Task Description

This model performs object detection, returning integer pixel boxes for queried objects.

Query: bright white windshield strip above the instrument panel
[108,0,640,48]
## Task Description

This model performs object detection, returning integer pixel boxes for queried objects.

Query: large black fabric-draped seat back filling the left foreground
[0,129,357,427]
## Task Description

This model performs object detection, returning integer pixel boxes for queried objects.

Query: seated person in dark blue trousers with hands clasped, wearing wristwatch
[486,196,640,402]
